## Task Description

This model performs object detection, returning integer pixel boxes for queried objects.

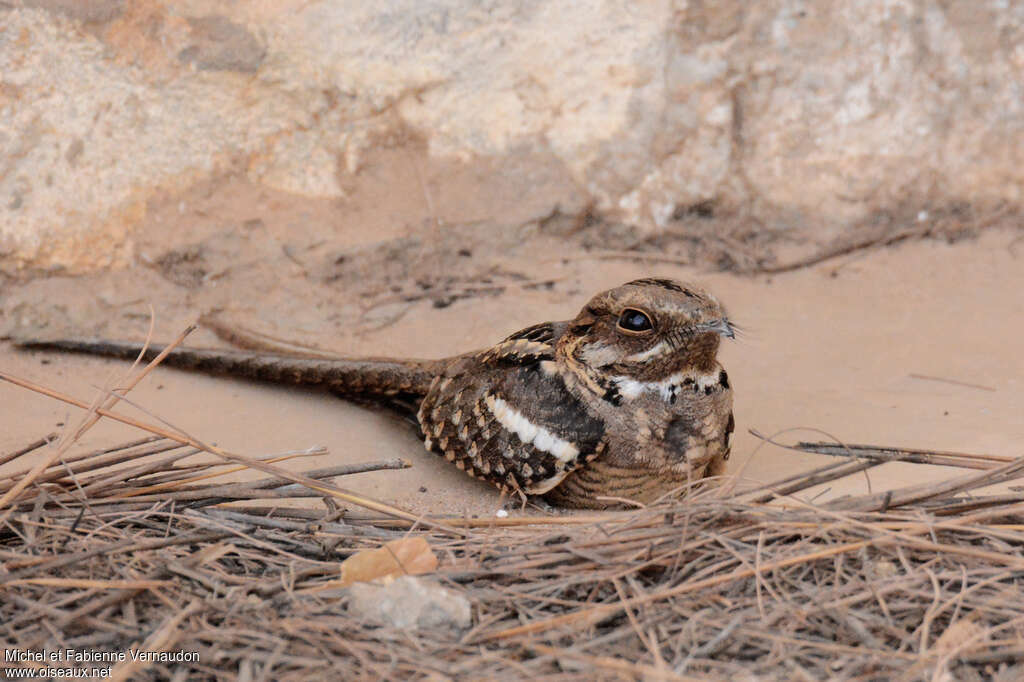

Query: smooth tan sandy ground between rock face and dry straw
[0,182,1024,515]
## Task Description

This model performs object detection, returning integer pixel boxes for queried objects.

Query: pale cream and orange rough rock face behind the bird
[0,0,1024,270]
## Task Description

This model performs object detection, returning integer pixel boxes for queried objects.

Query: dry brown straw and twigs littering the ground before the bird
[0,337,1024,681]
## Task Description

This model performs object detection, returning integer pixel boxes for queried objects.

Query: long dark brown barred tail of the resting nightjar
[16,339,443,402]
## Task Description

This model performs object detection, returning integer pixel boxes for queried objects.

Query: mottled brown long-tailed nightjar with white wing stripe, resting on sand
[20,279,734,509]
